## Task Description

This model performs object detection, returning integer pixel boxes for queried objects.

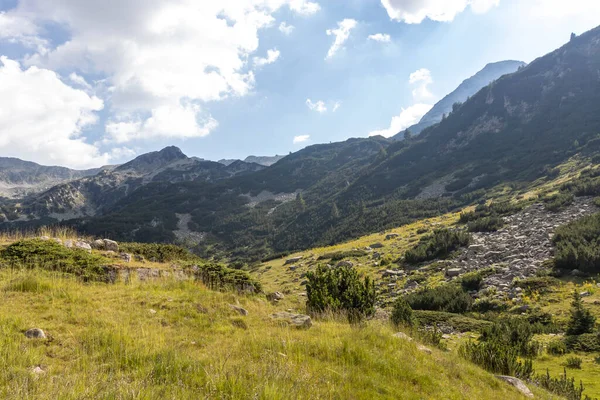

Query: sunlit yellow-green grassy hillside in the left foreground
[0,231,552,399]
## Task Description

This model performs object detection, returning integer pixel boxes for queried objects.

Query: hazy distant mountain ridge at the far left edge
[0,157,111,198]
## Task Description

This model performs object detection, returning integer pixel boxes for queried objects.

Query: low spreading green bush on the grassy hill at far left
[0,239,107,281]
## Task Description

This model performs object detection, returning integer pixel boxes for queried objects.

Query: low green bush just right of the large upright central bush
[405,284,473,314]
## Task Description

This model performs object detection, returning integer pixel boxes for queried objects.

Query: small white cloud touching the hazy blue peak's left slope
[369,68,433,137]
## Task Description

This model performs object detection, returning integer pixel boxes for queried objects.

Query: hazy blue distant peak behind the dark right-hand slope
[395,60,526,140]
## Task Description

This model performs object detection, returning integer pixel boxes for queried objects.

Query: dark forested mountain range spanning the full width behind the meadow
[0,28,600,260]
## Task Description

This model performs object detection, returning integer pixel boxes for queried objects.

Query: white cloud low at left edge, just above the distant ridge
[0,57,112,168]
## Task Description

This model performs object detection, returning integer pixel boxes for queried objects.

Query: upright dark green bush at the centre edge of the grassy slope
[306,265,377,322]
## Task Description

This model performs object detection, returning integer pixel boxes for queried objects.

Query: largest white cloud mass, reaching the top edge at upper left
[0,0,320,148]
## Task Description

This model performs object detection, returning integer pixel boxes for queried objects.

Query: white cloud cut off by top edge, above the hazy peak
[381,0,500,24]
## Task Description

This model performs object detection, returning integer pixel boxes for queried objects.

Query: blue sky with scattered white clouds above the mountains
[0,0,600,169]
